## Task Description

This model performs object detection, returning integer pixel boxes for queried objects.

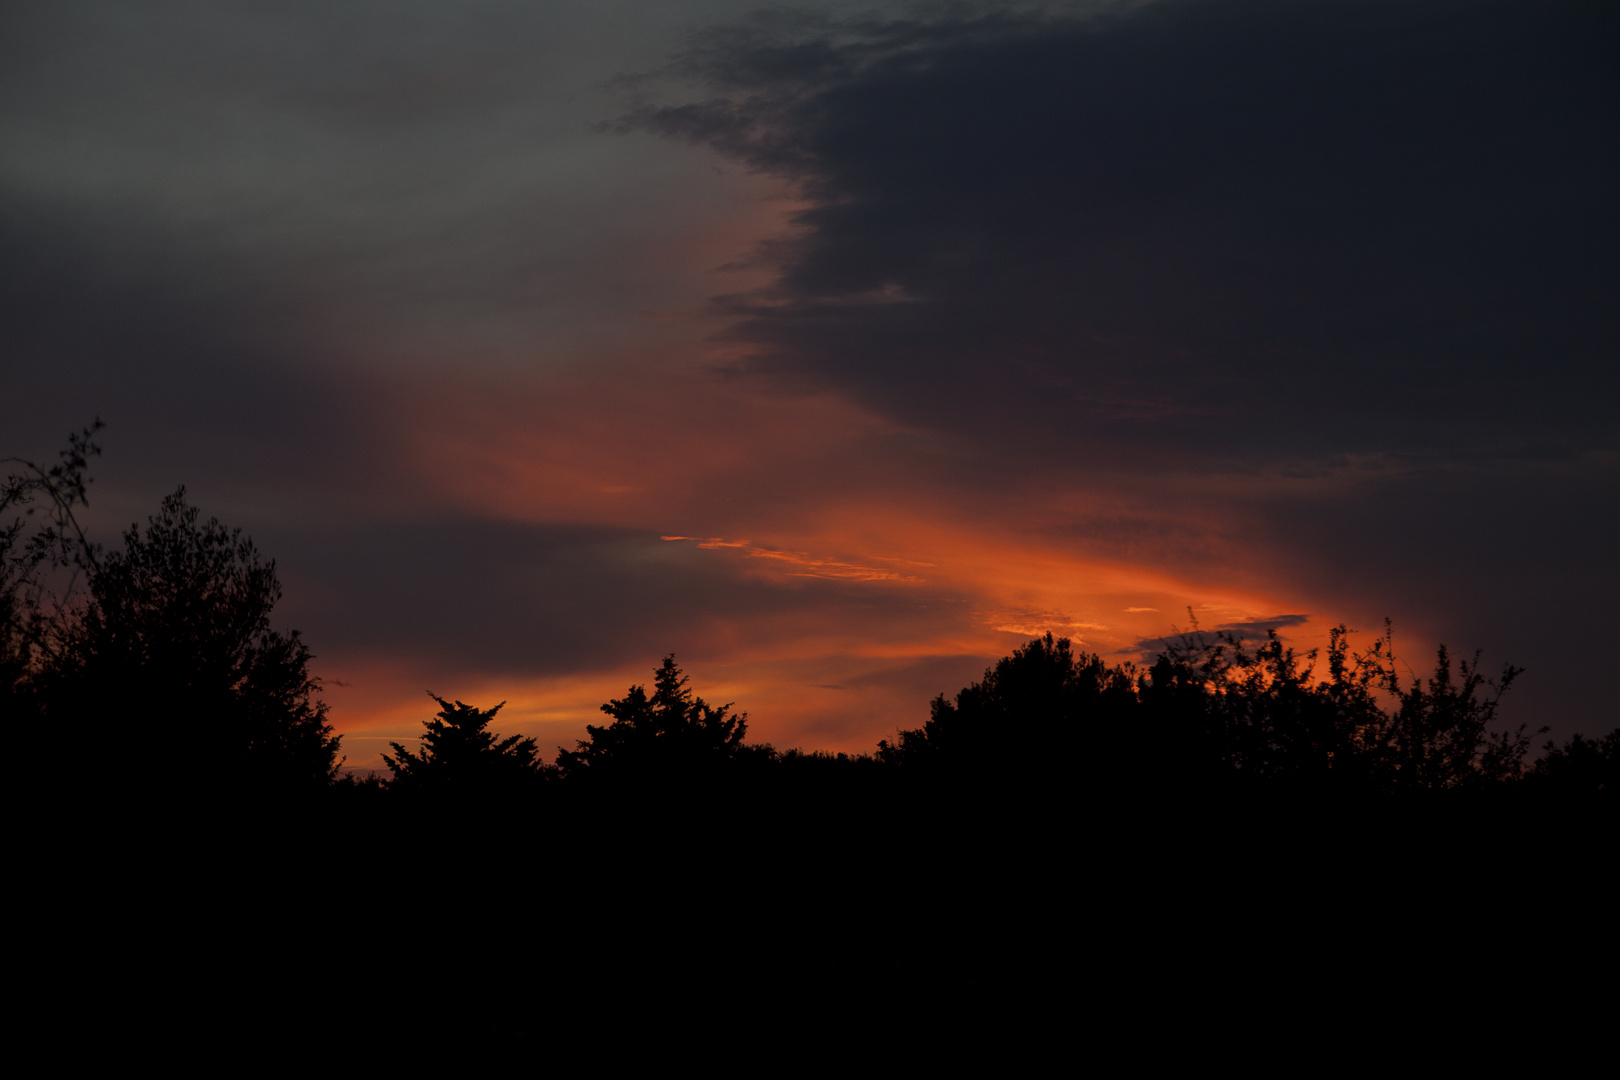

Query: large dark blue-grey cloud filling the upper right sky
[629,0,1620,466]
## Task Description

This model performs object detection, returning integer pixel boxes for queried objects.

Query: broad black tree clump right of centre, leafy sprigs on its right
[876,627,1531,792]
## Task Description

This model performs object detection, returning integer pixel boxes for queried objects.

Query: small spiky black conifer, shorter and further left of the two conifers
[382,695,546,793]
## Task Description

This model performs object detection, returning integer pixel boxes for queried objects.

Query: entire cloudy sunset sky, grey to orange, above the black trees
[0,0,1620,767]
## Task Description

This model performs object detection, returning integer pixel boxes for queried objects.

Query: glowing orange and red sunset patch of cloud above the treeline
[312,371,1328,767]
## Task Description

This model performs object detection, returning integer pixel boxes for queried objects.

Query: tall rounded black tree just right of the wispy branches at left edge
[41,487,339,790]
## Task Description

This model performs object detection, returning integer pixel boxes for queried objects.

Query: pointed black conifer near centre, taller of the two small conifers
[557,654,748,777]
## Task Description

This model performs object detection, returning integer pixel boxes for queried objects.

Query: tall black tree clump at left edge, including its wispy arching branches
[0,421,340,795]
